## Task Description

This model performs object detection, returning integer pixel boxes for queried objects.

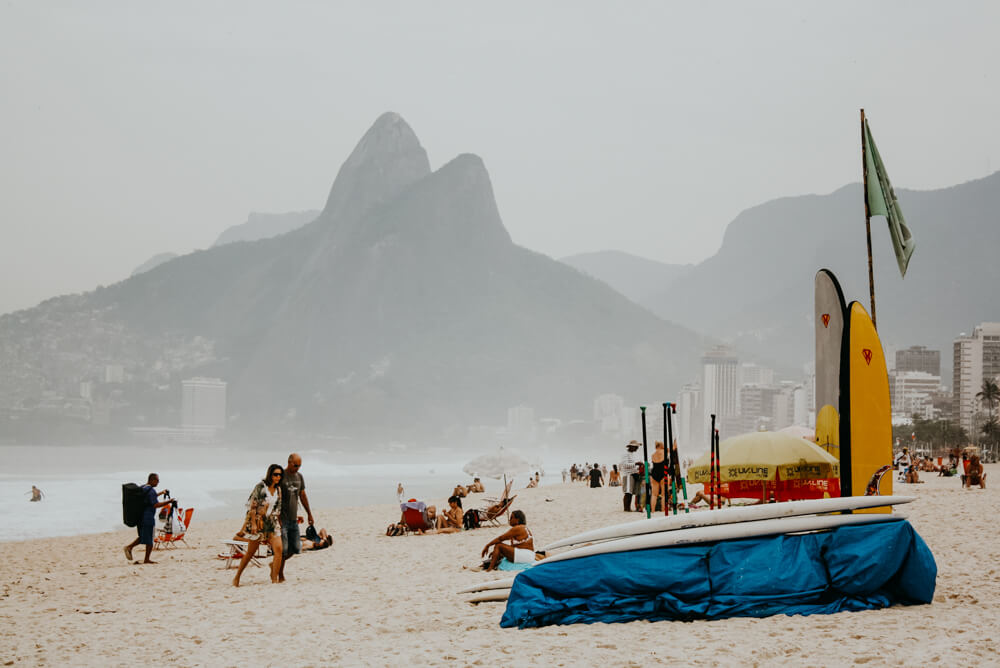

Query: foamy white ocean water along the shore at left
[0,446,560,541]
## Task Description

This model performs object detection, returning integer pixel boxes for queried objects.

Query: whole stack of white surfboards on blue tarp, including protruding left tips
[458,496,916,603]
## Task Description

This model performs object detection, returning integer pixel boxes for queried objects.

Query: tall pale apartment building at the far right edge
[951,322,1000,436]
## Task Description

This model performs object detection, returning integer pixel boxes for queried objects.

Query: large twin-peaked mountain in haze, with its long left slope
[0,114,704,438]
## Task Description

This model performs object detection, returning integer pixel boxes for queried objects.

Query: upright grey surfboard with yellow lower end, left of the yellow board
[814,269,847,458]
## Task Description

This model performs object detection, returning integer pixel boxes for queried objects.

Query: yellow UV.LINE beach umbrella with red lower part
[688,431,840,501]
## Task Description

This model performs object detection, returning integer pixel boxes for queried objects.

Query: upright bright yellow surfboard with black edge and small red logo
[840,302,892,513]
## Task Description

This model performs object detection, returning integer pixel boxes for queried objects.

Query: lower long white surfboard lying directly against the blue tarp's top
[535,513,905,568]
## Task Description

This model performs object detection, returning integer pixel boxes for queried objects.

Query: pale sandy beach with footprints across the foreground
[0,465,1000,666]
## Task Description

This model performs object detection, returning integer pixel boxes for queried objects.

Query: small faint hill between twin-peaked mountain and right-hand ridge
[559,251,694,304]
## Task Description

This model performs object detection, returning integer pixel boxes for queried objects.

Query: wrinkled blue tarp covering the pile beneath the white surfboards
[500,520,937,628]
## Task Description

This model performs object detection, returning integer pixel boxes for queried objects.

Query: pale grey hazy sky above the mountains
[0,0,1000,313]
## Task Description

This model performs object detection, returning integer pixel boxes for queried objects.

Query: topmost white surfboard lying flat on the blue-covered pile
[543,496,916,552]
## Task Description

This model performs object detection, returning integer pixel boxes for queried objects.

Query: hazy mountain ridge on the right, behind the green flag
[644,172,1000,385]
